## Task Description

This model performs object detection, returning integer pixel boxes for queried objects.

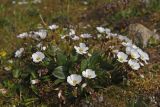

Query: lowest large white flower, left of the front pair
[67,74,82,86]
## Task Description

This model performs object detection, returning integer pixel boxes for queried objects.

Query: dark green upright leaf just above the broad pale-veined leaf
[57,53,67,65]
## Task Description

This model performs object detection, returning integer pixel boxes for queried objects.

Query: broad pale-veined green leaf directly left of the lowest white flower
[52,66,65,79]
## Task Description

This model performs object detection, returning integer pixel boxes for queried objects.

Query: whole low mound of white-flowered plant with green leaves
[6,24,149,103]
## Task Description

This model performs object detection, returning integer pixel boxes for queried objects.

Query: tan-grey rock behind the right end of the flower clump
[129,23,160,47]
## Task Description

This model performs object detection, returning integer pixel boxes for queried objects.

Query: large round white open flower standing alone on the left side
[32,52,45,63]
